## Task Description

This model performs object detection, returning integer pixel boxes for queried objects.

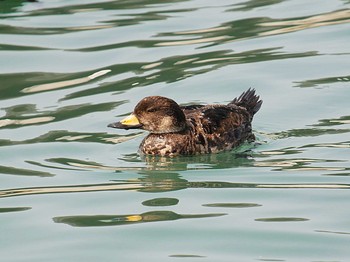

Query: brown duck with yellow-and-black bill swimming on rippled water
[108,89,262,156]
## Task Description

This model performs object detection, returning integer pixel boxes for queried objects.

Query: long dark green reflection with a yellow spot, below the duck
[53,211,226,227]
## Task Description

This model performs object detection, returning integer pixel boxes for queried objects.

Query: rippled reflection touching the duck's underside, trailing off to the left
[35,147,255,172]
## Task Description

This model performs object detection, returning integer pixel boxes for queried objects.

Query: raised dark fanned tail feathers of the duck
[229,88,262,115]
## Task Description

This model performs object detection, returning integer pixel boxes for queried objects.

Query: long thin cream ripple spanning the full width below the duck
[0,178,350,199]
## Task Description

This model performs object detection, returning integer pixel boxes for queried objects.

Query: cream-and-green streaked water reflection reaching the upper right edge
[155,9,350,46]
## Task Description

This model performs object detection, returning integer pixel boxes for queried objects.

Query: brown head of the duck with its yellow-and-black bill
[108,96,186,134]
